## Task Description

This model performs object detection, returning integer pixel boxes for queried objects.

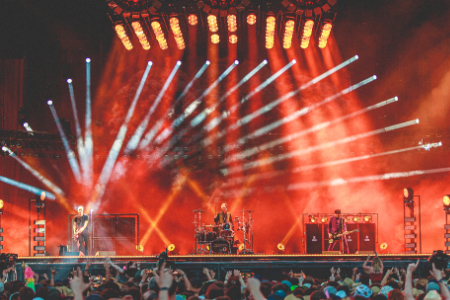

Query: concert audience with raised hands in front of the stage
[0,259,450,300]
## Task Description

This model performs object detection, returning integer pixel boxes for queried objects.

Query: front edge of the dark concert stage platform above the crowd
[18,254,431,280]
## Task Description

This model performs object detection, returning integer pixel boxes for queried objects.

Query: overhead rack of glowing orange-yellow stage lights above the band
[105,0,337,51]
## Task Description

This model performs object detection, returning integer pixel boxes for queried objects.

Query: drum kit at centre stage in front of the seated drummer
[193,209,254,254]
